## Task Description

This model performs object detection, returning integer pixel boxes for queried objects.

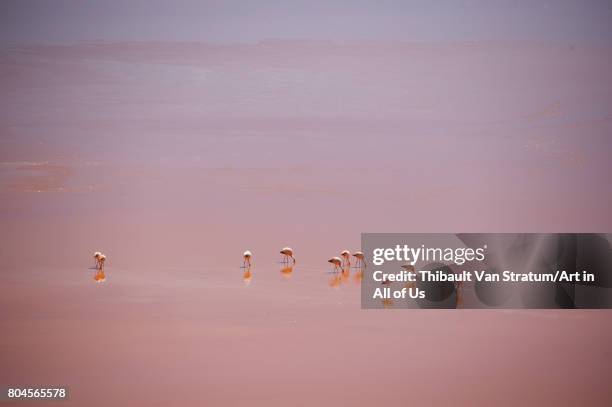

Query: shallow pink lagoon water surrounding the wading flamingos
[0,42,612,406]
